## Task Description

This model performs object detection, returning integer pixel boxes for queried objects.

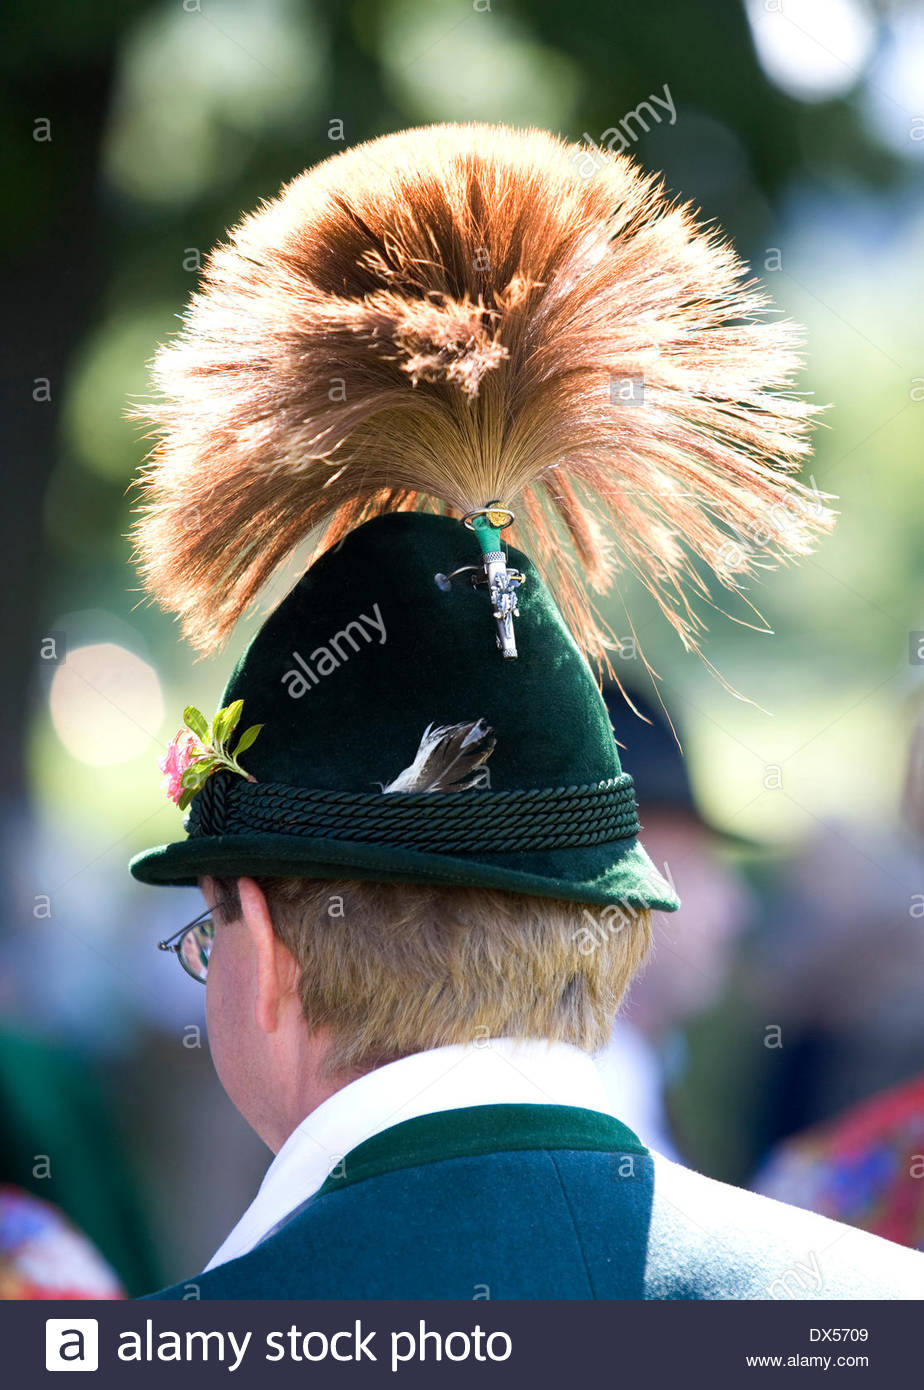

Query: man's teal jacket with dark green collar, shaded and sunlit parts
[144,1105,924,1300]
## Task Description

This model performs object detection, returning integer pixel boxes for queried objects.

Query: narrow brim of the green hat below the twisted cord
[129,835,679,912]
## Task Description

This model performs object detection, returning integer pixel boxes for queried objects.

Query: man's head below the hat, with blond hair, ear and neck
[203,878,650,1150]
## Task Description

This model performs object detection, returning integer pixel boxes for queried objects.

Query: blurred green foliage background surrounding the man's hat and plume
[0,0,924,1287]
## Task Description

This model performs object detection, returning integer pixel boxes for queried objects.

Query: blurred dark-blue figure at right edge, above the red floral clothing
[748,821,924,1141]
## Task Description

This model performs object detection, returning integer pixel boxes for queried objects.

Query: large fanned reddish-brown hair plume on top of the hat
[127,125,831,655]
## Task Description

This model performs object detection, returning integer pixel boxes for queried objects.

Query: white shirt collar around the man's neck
[206,1038,609,1269]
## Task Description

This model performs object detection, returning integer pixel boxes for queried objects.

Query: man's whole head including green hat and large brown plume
[132,125,831,1141]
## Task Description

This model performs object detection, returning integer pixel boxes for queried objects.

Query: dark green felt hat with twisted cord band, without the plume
[131,512,679,910]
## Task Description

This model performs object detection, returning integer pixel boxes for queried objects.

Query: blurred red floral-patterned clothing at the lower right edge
[754,1076,924,1250]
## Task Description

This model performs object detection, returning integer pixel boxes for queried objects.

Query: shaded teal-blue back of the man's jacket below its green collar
[143,1151,591,1300]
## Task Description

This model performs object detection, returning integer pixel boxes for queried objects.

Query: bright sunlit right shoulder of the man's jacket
[646,1154,924,1300]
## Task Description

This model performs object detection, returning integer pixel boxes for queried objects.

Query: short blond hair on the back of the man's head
[217,878,650,1072]
